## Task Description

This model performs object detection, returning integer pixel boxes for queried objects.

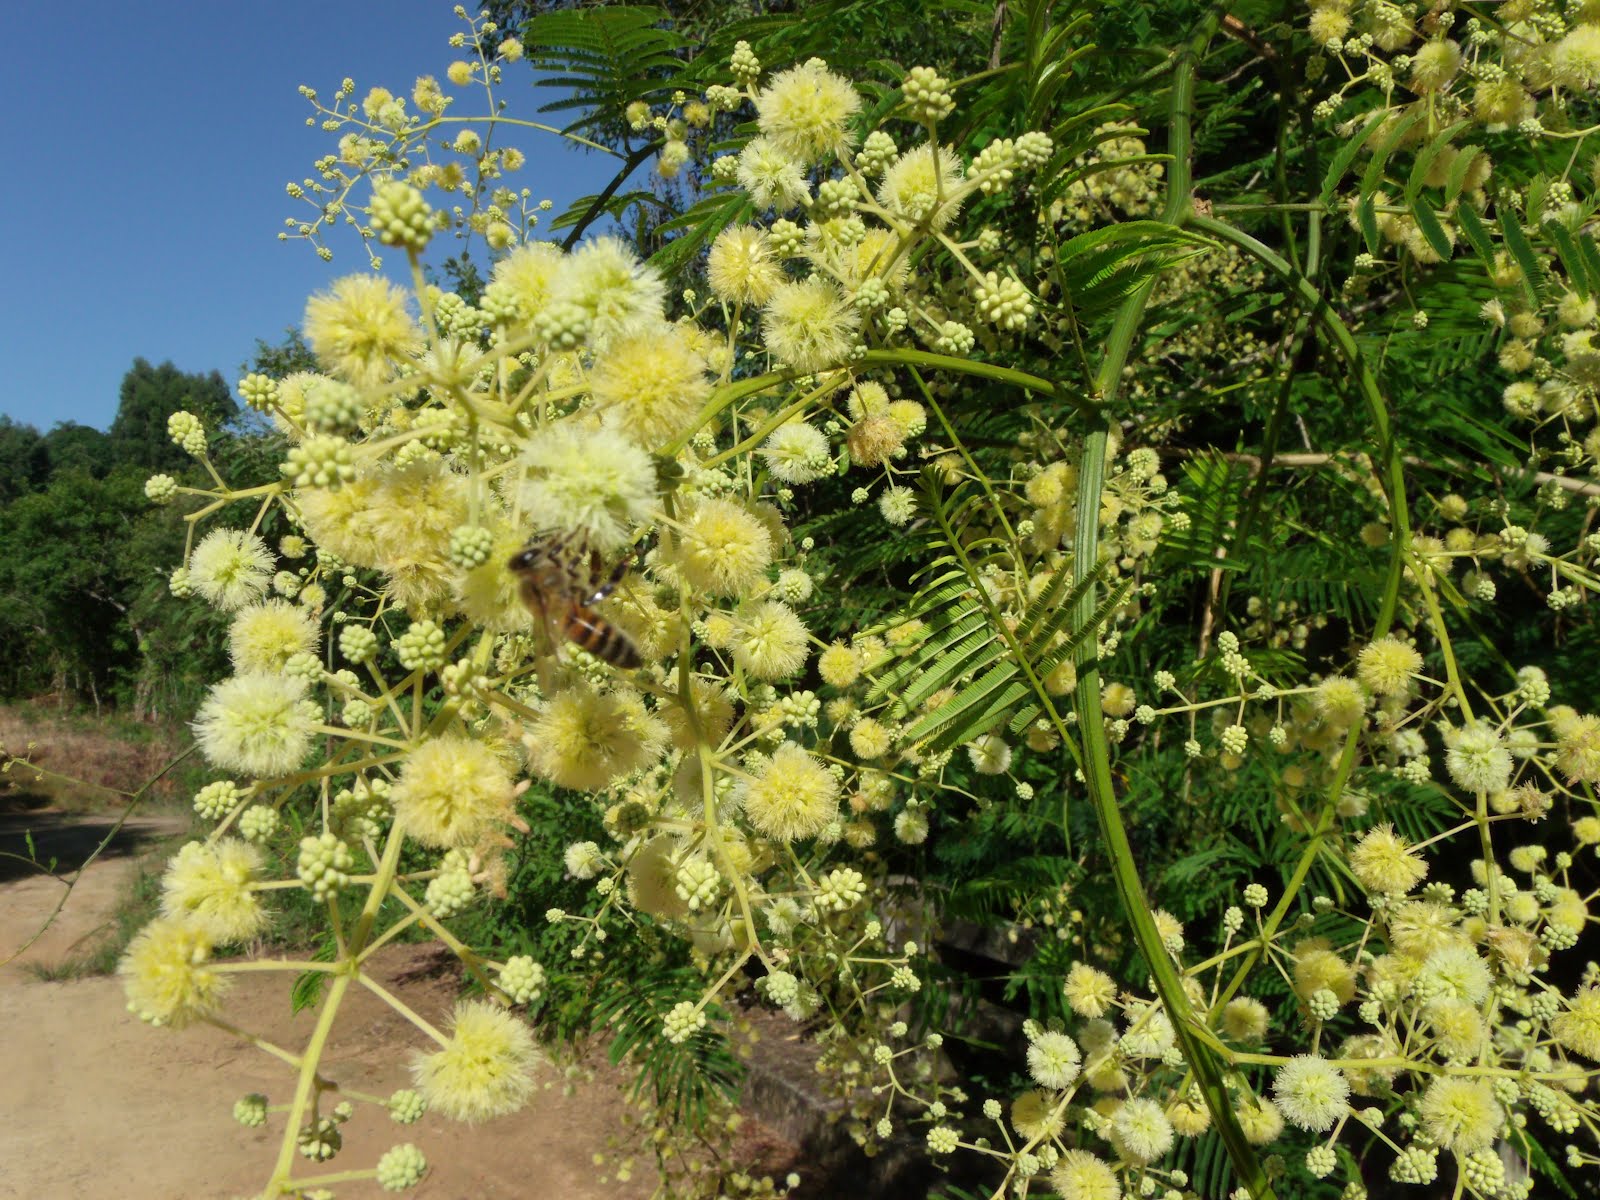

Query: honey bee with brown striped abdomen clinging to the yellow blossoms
[507,533,643,670]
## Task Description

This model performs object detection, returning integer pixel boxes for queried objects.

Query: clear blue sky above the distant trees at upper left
[0,0,630,429]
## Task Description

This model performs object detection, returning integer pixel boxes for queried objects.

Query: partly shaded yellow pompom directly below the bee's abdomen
[525,685,667,792]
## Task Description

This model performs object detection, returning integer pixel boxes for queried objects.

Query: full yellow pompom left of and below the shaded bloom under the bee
[389,733,514,850]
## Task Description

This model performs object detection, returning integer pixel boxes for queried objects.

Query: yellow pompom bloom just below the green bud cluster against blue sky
[306,275,422,387]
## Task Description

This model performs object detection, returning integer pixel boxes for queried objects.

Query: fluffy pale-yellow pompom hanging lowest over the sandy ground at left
[411,1000,539,1122]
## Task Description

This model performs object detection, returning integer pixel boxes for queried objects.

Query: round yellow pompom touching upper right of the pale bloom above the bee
[589,323,710,450]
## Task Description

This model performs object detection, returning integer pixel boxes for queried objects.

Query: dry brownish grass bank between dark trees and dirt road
[0,706,186,811]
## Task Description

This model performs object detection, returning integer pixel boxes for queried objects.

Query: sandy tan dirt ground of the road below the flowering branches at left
[0,813,654,1200]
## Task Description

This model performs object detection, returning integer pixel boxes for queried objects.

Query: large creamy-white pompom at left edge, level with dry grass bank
[194,672,317,779]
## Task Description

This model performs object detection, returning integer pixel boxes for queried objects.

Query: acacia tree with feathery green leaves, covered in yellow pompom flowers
[87,0,1600,1200]
